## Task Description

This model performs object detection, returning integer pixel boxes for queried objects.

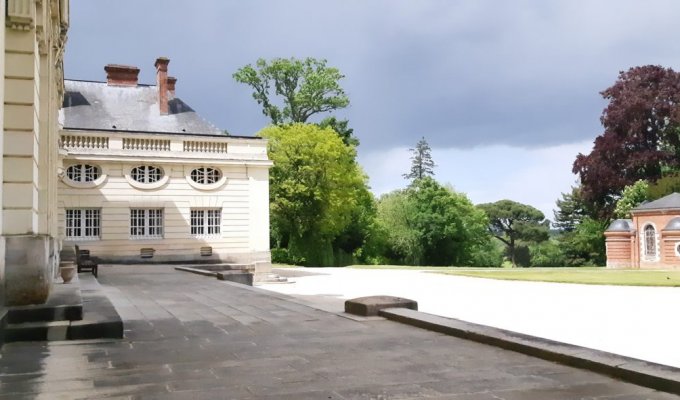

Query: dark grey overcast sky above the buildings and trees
[65,0,680,219]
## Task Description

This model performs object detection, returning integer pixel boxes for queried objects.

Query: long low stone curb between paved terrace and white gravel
[379,308,680,395]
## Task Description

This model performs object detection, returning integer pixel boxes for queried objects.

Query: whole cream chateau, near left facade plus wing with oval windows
[0,0,272,318]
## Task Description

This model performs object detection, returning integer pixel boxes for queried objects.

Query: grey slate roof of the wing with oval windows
[63,80,223,135]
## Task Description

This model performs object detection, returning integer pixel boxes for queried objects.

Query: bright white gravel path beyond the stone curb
[260,268,680,368]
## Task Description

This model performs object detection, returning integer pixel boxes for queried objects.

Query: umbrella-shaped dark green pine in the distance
[478,200,550,266]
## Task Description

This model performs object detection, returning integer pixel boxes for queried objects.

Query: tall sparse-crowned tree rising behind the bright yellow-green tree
[233,58,349,125]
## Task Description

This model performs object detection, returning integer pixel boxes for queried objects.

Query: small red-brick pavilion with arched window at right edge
[604,193,680,269]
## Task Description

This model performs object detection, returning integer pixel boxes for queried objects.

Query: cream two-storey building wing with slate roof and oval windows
[57,58,272,278]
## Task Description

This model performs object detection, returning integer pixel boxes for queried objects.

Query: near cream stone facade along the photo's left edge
[0,0,69,305]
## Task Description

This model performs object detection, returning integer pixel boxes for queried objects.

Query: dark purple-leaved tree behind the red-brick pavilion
[573,65,680,219]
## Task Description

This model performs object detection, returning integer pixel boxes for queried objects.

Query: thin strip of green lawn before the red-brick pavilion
[441,268,680,286]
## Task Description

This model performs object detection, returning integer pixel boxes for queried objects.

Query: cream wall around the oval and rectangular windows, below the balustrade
[58,158,269,262]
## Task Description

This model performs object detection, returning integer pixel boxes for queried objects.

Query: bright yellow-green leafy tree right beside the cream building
[259,124,366,266]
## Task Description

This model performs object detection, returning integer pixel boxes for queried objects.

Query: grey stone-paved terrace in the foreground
[0,266,677,400]
